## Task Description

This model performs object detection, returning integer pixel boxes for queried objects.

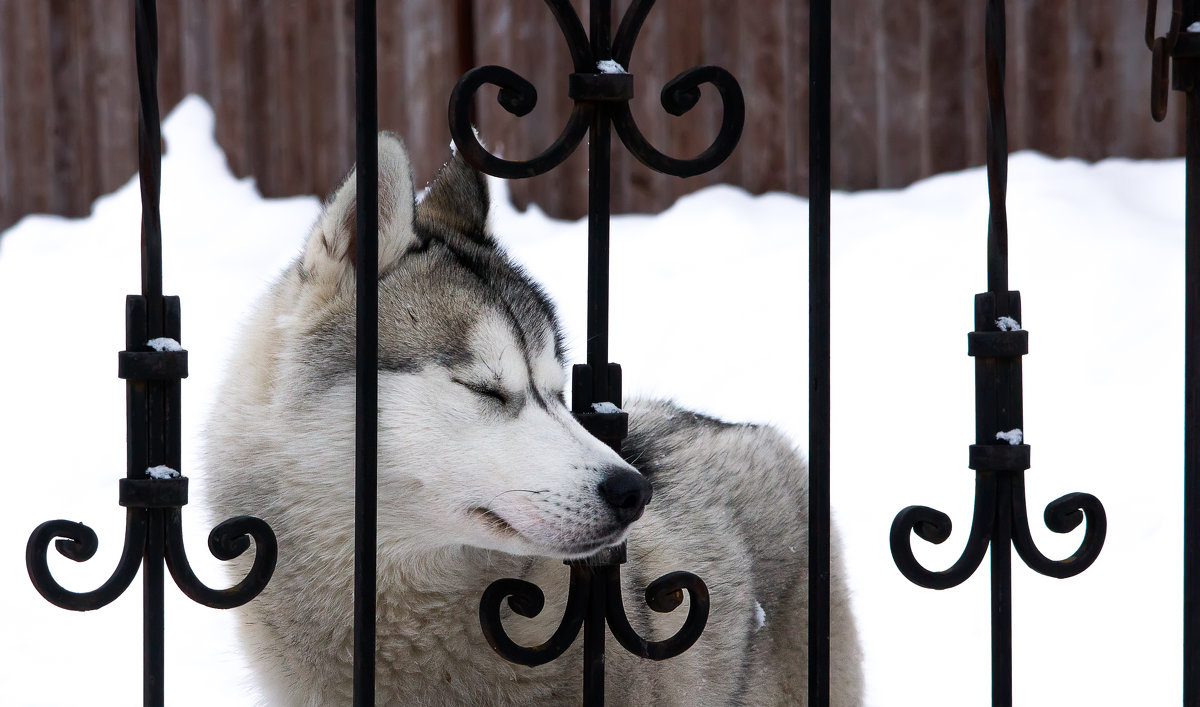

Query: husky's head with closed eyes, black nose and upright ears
[277,134,650,558]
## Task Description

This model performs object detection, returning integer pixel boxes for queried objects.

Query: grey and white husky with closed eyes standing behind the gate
[206,134,863,707]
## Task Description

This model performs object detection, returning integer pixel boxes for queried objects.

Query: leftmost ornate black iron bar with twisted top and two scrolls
[25,0,278,624]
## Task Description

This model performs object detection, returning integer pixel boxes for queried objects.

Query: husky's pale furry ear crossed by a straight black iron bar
[300,132,416,284]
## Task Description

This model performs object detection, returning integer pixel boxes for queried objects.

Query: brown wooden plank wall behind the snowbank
[0,0,1183,227]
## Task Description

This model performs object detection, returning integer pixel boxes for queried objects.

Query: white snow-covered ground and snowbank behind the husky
[0,98,1183,707]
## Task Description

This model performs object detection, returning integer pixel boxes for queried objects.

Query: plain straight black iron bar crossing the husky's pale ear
[354,0,379,707]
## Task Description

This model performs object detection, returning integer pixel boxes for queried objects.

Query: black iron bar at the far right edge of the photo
[1175,0,1200,705]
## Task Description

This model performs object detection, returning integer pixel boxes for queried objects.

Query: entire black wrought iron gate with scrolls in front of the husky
[26,0,1200,707]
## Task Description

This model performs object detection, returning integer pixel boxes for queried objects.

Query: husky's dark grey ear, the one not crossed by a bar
[416,151,493,245]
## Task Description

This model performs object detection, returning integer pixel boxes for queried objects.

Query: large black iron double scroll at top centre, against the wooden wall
[449,0,745,179]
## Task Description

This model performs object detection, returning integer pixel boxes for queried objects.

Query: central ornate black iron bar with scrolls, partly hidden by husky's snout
[449,0,729,676]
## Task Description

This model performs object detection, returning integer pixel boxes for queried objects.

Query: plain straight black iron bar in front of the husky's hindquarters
[809,0,832,707]
